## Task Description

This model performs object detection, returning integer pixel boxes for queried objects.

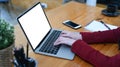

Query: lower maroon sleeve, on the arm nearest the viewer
[71,40,120,67]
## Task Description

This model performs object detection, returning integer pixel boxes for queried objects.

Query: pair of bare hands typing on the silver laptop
[54,31,82,46]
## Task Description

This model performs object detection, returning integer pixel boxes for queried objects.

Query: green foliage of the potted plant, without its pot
[0,19,14,49]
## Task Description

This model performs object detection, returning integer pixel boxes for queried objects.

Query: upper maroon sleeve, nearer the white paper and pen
[80,27,120,43]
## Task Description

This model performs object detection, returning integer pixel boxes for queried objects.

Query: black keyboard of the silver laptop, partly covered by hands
[40,30,61,54]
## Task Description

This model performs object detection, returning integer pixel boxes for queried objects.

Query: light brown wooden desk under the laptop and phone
[15,2,120,67]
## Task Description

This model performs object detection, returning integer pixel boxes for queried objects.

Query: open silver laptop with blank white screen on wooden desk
[17,2,74,60]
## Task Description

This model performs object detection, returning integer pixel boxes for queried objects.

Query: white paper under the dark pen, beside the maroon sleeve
[84,20,118,32]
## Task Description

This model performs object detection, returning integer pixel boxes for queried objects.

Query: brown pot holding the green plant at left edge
[0,44,14,67]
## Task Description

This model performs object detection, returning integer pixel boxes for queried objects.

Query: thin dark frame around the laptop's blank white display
[17,2,52,51]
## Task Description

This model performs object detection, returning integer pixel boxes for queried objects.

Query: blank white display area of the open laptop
[18,3,51,49]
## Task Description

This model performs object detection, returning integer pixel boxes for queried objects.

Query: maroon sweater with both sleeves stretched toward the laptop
[71,27,120,67]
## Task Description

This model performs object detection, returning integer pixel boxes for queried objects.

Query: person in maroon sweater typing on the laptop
[54,27,120,67]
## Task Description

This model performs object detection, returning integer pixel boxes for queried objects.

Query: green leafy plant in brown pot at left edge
[0,19,14,67]
